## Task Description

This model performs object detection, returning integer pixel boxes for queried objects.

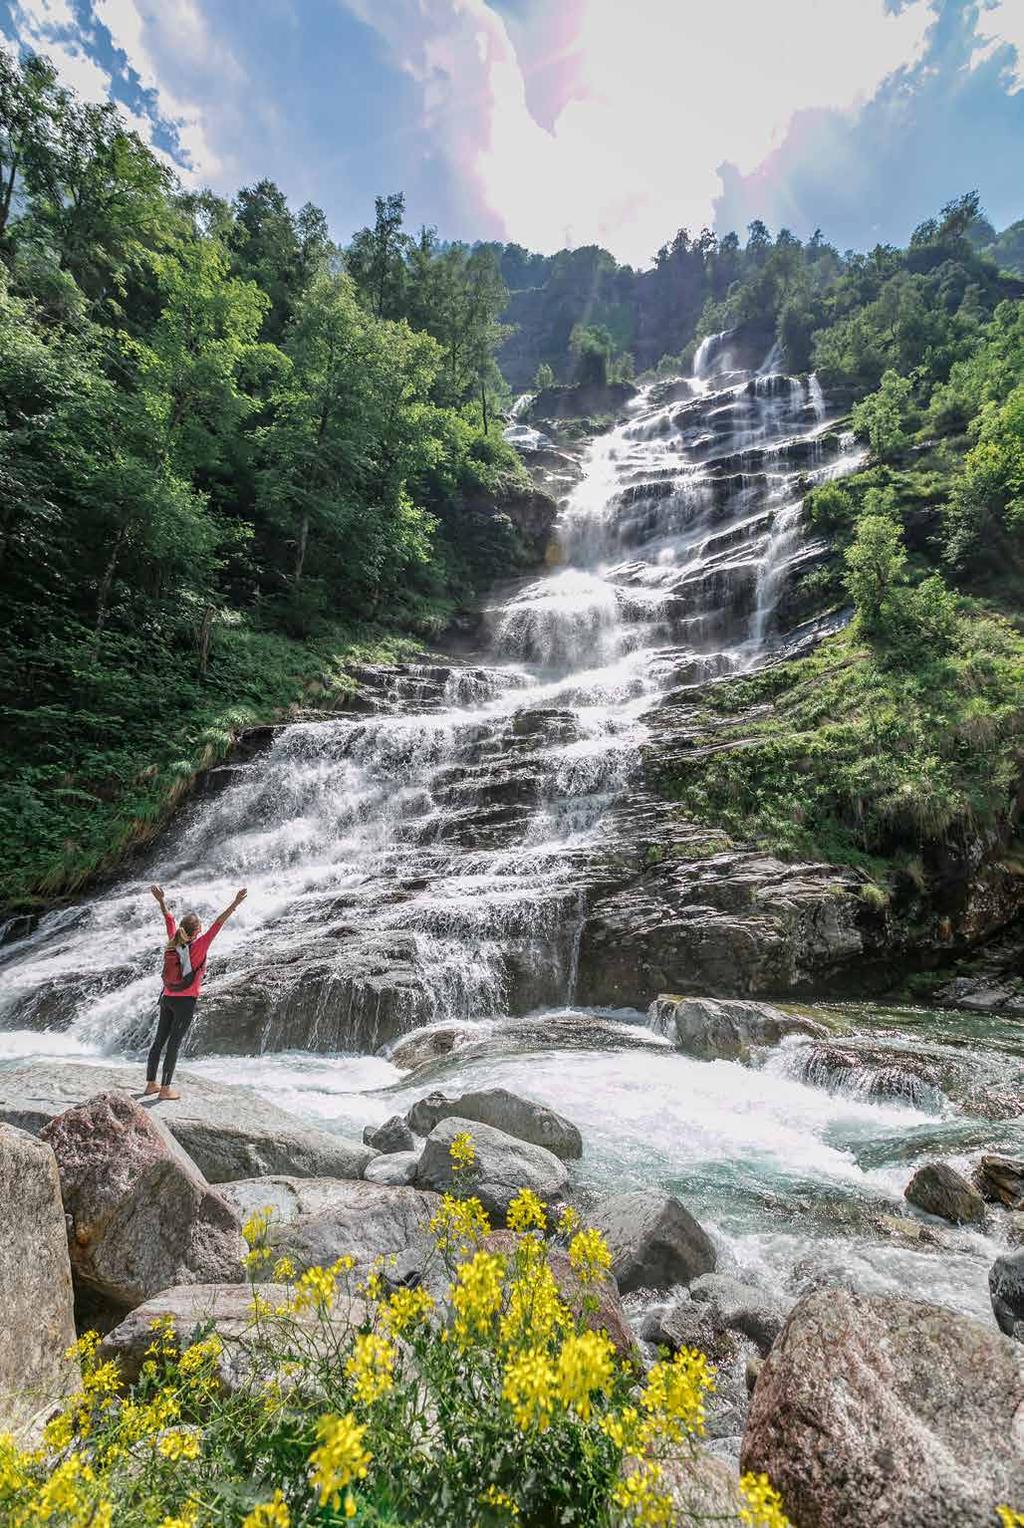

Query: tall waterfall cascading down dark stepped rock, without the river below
[0,362,859,1054]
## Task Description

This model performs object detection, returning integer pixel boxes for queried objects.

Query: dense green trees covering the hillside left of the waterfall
[0,50,524,900]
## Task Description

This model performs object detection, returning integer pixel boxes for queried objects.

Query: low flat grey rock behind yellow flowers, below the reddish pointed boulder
[99,1284,367,1390]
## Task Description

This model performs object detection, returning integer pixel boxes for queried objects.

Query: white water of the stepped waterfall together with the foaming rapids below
[0,363,1014,1332]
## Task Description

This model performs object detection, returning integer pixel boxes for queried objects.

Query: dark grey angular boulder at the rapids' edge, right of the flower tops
[590,1189,715,1294]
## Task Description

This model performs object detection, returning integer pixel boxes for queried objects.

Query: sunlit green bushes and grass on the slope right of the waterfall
[662,278,1024,883]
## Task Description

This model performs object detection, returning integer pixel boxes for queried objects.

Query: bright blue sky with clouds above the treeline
[0,0,1024,266]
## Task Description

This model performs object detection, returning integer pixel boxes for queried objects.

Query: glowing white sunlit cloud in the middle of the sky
[342,0,941,263]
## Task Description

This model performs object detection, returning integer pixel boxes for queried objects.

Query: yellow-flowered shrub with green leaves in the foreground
[0,1138,787,1528]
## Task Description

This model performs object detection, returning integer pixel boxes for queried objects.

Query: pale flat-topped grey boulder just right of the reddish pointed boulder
[225,1177,439,1274]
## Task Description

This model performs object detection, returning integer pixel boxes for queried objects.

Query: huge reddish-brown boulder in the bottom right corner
[740,1290,1024,1528]
